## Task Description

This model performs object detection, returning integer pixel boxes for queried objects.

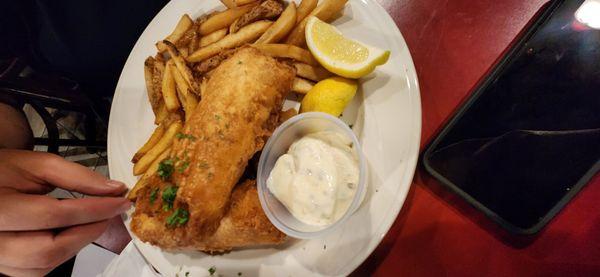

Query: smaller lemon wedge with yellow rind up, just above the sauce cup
[300,76,358,116]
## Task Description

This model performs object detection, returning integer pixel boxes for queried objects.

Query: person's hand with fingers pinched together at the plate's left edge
[0,149,131,276]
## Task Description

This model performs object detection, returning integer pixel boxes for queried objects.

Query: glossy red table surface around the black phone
[353,0,600,276]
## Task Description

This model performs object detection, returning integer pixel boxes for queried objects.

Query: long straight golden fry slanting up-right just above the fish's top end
[187,20,273,62]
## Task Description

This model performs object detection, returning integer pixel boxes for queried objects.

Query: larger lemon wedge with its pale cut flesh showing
[304,16,390,79]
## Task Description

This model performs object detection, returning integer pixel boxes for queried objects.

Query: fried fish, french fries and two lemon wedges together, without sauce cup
[127,0,389,253]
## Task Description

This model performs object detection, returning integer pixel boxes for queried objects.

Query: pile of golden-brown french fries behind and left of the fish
[129,0,348,199]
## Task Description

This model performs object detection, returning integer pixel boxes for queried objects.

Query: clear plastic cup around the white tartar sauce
[257,112,367,239]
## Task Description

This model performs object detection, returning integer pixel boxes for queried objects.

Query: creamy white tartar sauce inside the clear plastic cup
[267,131,359,226]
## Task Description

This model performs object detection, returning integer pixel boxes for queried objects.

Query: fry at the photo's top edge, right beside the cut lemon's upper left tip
[285,0,348,46]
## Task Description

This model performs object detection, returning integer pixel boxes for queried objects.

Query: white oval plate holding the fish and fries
[108,0,421,276]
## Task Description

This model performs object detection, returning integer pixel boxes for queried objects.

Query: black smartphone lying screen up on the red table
[422,0,600,234]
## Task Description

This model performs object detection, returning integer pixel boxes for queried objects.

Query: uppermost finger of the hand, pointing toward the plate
[1,149,127,195]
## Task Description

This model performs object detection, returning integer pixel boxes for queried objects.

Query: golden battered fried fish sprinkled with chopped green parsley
[131,47,295,251]
